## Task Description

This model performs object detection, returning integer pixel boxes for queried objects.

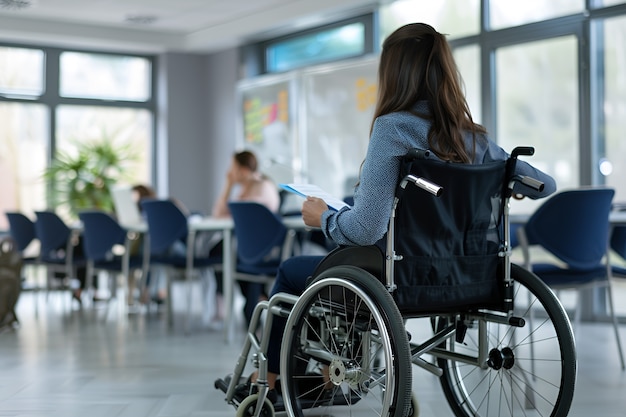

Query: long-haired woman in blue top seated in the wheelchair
[218,23,556,417]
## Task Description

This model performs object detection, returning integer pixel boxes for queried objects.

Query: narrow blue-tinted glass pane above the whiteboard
[266,22,365,72]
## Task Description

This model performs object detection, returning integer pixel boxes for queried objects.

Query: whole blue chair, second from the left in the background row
[35,211,85,300]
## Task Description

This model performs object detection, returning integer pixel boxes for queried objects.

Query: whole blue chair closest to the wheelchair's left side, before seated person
[228,201,293,325]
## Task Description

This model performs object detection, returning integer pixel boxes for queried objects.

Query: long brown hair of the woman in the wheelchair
[374,23,486,163]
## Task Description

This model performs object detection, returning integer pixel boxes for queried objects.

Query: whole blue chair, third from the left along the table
[78,210,143,306]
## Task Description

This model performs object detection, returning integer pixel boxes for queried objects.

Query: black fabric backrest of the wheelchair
[387,152,507,315]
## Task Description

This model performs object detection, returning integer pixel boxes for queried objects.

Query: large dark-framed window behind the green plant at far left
[0,46,154,230]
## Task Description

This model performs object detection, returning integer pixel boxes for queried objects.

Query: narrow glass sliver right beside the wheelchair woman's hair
[452,45,482,123]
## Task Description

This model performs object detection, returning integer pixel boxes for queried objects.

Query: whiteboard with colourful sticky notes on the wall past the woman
[237,57,378,197]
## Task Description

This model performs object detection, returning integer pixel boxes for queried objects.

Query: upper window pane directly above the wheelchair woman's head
[380,0,480,43]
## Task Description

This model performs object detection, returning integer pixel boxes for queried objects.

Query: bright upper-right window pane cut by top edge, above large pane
[489,0,585,29]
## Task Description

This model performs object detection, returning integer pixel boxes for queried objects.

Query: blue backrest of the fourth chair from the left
[140,199,188,255]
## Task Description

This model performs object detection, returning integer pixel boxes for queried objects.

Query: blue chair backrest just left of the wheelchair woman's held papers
[228,201,287,265]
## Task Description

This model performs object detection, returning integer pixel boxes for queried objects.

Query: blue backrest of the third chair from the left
[78,210,126,261]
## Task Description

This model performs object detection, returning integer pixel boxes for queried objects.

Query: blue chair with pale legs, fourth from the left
[140,199,222,331]
